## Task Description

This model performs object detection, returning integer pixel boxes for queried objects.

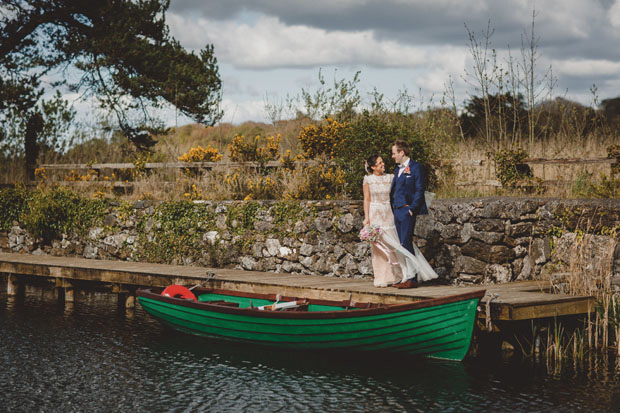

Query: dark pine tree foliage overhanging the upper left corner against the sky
[0,0,221,148]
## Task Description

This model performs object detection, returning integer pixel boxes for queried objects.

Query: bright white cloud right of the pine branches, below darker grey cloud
[168,15,430,69]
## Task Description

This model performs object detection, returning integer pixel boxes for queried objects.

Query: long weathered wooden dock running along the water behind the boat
[0,249,594,321]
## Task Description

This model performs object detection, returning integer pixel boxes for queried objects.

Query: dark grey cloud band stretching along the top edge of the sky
[171,0,620,58]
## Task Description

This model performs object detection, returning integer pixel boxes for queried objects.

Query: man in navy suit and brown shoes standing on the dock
[390,140,428,288]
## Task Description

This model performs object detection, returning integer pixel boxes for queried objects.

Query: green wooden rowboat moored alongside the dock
[137,288,485,361]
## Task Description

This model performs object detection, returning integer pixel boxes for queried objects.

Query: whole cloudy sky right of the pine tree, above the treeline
[160,0,620,123]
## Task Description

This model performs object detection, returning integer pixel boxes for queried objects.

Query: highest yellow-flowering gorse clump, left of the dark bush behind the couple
[298,118,348,159]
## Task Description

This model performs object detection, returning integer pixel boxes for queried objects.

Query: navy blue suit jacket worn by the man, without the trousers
[390,159,428,215]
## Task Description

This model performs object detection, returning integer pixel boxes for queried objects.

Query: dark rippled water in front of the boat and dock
[0,288,620,412]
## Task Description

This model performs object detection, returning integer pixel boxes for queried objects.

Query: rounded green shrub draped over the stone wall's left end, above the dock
[19,187,108,241]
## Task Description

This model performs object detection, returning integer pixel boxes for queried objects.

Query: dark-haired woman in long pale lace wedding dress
[363,155,437,287]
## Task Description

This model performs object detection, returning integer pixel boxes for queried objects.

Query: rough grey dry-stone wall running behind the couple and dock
[0,198,620,283]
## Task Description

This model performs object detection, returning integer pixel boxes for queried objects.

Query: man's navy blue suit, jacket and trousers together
[390,159,428,255]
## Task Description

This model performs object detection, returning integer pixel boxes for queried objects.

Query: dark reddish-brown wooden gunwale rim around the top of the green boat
[136,288,486,319]
